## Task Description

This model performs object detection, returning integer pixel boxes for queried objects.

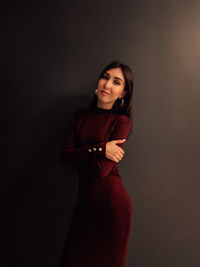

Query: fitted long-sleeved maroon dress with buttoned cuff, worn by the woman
[63,107,132,267]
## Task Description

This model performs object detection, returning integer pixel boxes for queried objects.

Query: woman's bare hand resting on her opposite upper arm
[105,139,126,162]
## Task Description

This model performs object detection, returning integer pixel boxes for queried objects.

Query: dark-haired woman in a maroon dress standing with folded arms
[62,61,133,267]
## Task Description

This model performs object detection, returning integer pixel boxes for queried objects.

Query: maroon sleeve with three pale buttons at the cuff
[61,110,106,170]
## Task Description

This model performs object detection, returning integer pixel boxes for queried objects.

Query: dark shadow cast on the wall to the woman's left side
[3,92,89,267]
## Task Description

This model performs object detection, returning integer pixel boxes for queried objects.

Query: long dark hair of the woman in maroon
[89,60,134,118]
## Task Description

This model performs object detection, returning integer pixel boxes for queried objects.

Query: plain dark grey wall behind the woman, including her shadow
[0,0,200,267]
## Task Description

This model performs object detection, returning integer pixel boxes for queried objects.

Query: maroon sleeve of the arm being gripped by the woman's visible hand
[78,115,131,178]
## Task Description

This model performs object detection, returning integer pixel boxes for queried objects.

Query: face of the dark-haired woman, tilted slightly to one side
[97,68,125,109]
